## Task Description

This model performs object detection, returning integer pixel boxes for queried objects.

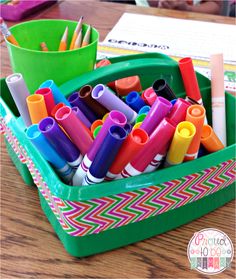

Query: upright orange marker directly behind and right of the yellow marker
[184,105,206,161]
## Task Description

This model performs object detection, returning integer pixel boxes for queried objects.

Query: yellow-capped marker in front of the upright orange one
[165,121,196,166]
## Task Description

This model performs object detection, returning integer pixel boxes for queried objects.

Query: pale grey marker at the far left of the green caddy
[6,73,31,127]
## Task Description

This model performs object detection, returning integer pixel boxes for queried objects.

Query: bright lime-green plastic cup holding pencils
[6,19,99,93]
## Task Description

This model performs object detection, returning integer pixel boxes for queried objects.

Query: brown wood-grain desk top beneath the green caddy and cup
[1,0,236,278]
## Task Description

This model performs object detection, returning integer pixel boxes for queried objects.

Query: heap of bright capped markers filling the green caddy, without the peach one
[6,53,226,185]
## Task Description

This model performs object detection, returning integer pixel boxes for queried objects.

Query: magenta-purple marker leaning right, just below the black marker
[141,97,172,136]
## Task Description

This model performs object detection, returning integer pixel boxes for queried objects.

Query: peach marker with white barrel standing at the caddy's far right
[210,53,226,146]
